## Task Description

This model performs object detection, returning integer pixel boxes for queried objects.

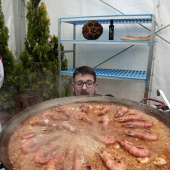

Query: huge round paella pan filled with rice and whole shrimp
[0,96,170,170]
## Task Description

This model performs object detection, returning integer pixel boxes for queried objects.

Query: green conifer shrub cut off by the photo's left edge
[0,0,16,112]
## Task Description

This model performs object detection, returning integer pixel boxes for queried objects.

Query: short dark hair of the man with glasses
[73,66,96,82]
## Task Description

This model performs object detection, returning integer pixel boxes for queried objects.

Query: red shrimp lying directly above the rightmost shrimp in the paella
[122,120,153,128]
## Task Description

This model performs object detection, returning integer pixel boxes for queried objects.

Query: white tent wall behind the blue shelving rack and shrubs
[2,0,170,104]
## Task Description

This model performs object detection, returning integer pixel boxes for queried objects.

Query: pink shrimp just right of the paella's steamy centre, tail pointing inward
[92,134,117,145]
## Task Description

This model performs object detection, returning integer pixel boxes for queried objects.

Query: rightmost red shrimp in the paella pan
[125,129,158,141]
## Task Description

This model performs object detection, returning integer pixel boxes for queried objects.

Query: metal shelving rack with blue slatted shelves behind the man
[58,14,155,97]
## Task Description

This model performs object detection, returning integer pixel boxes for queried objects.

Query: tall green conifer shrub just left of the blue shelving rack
[16,0,69,100]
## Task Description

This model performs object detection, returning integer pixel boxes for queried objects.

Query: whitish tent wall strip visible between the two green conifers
[1,0,26,58]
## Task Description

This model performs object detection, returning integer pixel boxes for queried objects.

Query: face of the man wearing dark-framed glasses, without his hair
[72,73,97,96]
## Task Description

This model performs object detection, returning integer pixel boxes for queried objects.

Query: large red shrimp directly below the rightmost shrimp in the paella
[117,139,150,157]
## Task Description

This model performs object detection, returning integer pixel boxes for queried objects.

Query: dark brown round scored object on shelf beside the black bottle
[82,20,103,40]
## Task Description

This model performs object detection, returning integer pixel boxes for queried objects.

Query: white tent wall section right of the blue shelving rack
[151,0,170,104]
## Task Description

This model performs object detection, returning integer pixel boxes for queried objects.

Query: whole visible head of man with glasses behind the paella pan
[72,66,97,96]
